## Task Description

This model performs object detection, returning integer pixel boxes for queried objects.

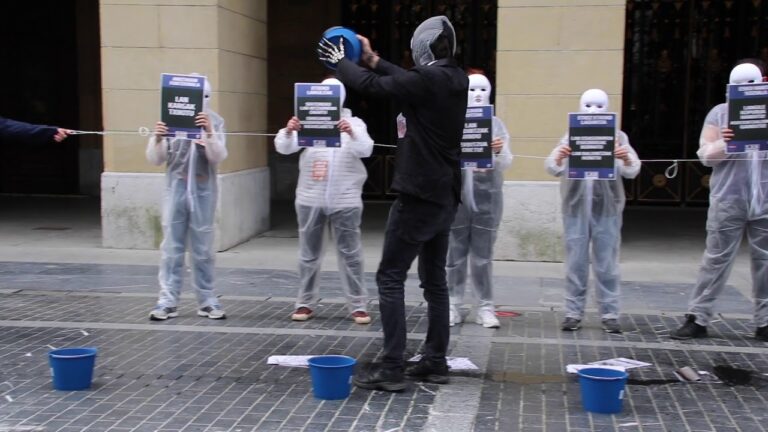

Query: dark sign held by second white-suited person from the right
[568,113,616,180]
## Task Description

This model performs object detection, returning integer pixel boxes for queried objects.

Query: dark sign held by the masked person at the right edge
[725,83,768,153]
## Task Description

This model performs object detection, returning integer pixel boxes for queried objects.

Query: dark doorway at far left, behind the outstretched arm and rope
[0,0,102,195]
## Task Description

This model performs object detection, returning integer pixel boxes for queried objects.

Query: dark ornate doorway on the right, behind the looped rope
[623,0,768,206]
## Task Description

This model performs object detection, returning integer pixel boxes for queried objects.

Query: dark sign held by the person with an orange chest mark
[294,83,341,147]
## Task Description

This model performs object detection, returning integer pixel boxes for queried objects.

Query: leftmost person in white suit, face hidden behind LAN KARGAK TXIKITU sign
[146,75,227,320]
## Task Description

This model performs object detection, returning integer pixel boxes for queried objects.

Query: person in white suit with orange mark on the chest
[275,78,373,324]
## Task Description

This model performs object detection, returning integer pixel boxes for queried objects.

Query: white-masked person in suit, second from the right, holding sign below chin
[545,89,640,333]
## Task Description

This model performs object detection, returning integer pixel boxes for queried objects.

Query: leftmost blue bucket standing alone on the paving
[48,348,97,390]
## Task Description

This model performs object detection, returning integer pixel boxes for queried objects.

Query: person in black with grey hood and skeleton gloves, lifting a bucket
[318,16,469,391]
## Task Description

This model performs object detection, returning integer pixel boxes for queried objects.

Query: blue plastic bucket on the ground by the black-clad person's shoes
[308,355,357,400]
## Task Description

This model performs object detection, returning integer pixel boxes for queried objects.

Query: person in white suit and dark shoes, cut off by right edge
[670,63,768,341]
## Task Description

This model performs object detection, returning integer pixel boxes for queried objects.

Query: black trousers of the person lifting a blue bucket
[376,194,456,369]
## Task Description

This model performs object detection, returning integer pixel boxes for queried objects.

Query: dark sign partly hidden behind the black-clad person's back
[461,105,493,168]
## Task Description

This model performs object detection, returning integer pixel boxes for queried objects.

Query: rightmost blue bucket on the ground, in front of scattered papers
[578,368,628,414]
